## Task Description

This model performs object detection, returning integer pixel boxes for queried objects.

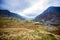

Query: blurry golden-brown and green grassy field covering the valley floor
[0,18,60,40]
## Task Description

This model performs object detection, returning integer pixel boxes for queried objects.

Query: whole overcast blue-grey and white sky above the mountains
[0,0,60,19]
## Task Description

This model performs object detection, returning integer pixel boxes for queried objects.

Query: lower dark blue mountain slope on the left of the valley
[0,10,24,20]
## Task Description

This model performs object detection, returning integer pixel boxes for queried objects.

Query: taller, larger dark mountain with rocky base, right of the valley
[34,7,60,25]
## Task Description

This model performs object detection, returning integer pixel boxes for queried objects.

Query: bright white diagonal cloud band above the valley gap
[17,0,48,17]
